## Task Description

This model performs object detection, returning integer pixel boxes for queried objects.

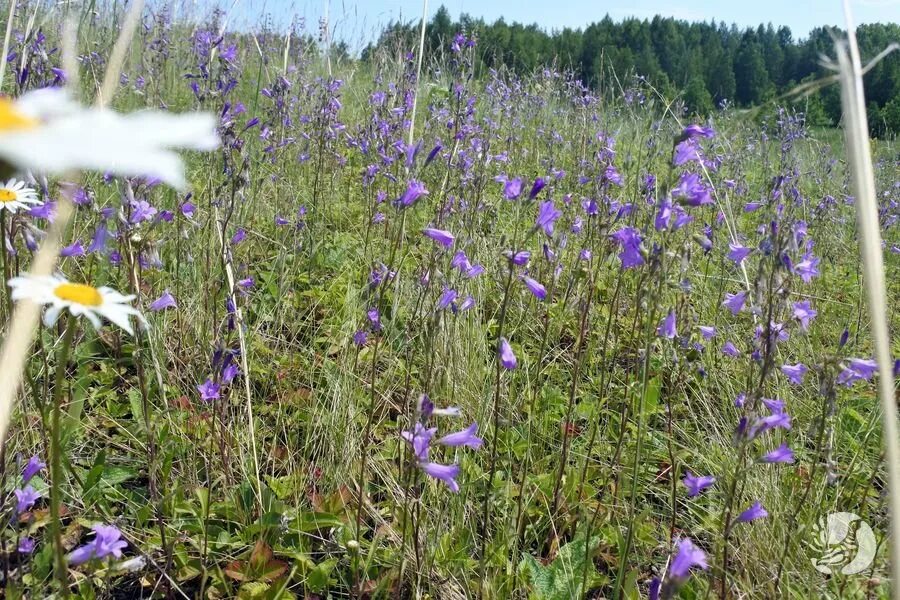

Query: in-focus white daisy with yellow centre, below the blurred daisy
[9,275,147,335]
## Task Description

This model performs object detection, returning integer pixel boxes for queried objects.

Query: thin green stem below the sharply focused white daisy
[50,314,77,597]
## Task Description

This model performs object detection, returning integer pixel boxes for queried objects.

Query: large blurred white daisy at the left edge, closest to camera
[0,88,219,188]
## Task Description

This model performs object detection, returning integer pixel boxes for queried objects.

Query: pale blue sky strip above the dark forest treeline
[221,0,900,47]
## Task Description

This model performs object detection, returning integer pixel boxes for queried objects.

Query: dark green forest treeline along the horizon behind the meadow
[362,6,900,136]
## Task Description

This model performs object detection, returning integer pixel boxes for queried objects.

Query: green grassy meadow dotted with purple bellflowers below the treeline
[0,5,900,599]
